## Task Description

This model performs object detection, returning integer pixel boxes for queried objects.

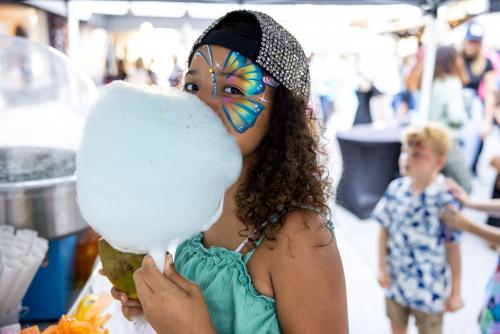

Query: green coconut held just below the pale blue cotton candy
[99,239,145,299]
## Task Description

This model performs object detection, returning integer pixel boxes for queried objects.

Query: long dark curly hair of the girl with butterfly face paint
[235,85,333,244]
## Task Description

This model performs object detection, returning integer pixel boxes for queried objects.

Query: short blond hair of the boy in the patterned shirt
[402,123,451,156]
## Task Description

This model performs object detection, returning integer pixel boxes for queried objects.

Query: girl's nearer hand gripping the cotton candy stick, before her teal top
[134,254,216,334]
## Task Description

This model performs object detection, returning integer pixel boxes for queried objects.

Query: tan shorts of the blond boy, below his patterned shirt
[385,298,443,334]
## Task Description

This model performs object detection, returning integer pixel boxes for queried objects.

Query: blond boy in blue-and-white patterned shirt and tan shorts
[372,124,463,334]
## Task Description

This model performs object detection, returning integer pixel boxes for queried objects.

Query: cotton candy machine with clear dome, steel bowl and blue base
[0,35,97,321]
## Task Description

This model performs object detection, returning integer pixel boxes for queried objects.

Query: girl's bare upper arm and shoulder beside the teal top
[270,210,349,334]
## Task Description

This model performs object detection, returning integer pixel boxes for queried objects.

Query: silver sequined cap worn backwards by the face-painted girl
[189,10,311,100]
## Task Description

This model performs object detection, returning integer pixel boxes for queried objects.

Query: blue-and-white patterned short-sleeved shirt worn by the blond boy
[372,174,460,314]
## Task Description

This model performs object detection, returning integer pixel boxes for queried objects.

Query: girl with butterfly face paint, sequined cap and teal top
[109,10,348,333]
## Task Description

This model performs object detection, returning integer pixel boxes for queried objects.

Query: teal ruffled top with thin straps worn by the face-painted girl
[174,210,333,334]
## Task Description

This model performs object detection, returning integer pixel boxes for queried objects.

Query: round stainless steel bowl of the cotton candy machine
[0,147,88,239]
